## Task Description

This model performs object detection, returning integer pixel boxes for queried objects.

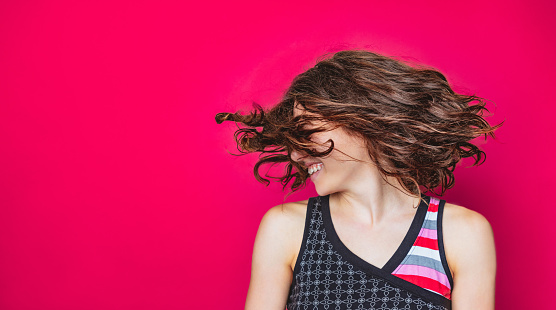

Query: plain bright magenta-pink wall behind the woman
[0,1,556,310]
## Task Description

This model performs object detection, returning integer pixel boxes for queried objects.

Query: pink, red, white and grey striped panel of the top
[392,197,451,299]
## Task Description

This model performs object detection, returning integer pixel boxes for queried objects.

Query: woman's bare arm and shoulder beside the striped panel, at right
[443,204,496,310]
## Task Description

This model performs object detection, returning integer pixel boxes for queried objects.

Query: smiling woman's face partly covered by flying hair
[291,106,378,196]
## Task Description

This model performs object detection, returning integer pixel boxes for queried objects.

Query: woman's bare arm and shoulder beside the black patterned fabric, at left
[245,203,306,310]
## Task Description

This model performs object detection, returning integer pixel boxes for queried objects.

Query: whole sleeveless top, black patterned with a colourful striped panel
[287,194,454,310]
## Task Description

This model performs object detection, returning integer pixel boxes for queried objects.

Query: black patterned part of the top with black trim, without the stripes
[287,195,453,310]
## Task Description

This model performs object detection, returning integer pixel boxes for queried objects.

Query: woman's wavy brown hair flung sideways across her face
[215,50,503,196]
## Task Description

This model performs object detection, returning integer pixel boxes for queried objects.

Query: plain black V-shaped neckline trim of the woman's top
[322,194,430,274]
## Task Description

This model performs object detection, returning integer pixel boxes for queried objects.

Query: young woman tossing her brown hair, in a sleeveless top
[216,50,502,310]
